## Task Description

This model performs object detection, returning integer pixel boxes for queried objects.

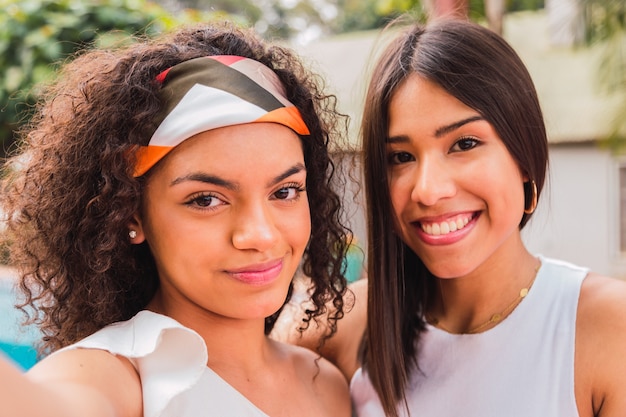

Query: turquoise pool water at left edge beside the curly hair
[0,271,39,369]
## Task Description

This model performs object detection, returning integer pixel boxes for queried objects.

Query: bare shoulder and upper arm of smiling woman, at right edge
[576,273,626,417]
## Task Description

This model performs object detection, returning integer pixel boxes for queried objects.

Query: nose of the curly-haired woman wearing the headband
[232,203,279,252]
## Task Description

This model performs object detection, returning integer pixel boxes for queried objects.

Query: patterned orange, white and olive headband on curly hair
[134,55,310,177]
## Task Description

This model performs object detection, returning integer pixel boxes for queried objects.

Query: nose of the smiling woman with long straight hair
[411,158,457,206]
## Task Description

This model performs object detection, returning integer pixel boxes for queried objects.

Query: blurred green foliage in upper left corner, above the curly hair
[0,0,219,155]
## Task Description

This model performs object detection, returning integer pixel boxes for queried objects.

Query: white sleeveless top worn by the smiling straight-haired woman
[350,257,588,417]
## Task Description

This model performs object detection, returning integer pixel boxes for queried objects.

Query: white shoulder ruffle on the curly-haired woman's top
[57,311,208,417]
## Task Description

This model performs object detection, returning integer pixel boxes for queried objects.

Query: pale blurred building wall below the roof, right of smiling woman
[523,144,626,278]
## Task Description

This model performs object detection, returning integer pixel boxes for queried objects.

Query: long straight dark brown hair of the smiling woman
[361,20,548,417]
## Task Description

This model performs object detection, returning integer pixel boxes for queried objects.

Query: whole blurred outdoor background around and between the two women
[0,0,626,368]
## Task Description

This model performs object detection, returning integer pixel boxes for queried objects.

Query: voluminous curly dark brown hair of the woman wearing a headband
[0,18,349,352]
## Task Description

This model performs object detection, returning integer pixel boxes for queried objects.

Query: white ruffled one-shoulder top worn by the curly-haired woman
[54,311,268,417]
